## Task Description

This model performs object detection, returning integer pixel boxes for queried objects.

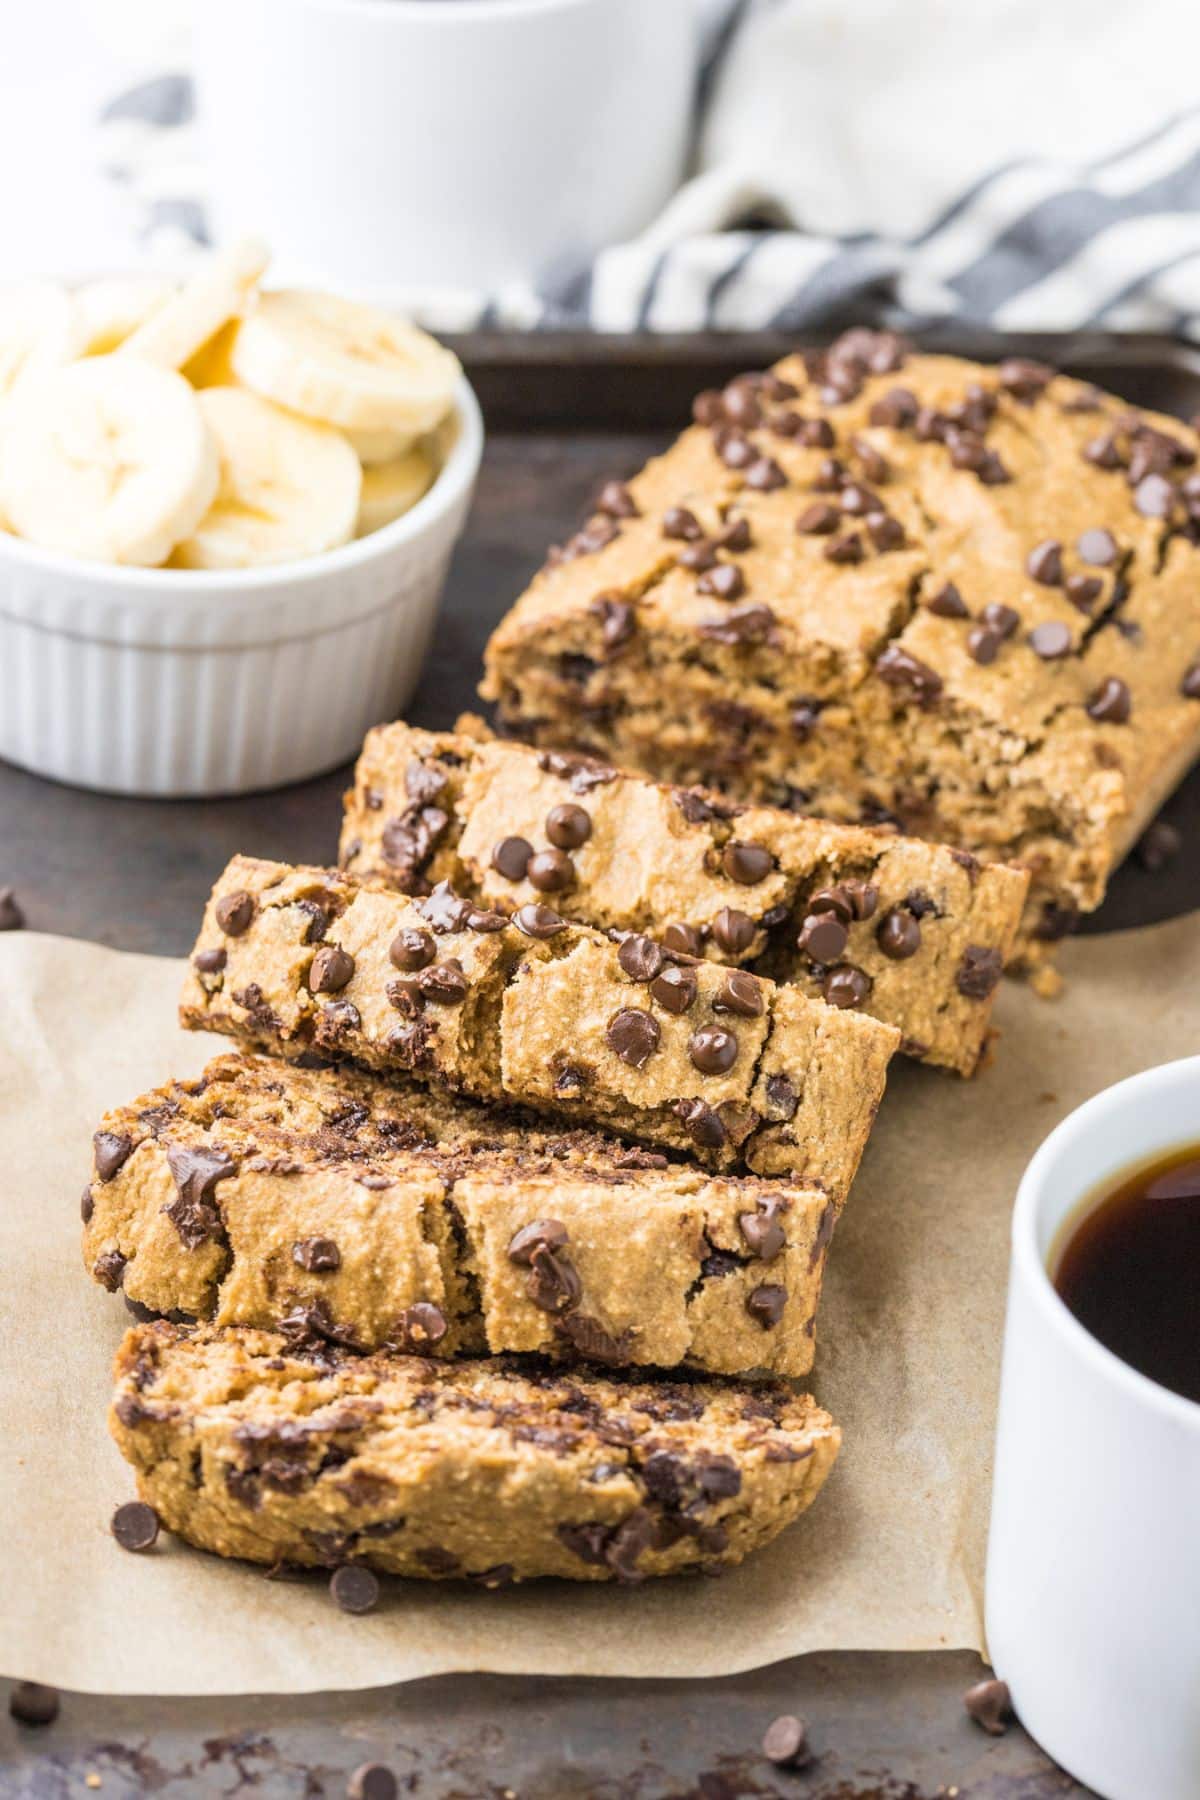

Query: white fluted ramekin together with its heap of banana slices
[0,241,484,796]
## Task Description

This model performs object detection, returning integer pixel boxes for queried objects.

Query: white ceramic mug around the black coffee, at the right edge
[986,1057,1200,1800]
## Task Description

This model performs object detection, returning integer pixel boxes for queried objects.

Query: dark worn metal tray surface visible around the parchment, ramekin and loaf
[0,331,1200,1800]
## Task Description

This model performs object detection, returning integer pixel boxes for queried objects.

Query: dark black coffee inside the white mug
[1051,1145,1200,1400]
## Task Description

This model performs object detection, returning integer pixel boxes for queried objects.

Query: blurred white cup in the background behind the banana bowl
[194,0,700,293]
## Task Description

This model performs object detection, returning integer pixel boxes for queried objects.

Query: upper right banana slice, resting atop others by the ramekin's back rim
[234,288,459,437]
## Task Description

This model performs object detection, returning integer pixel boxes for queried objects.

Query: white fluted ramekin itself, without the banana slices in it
[0,378,484,796]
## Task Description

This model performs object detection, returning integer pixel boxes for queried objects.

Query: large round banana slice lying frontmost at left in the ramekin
[0,355,219,565]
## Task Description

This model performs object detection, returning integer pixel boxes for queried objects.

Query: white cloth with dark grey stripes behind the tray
[103,0,1200,342]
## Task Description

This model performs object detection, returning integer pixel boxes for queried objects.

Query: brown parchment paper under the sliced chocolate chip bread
[0,916,1200,1694]
